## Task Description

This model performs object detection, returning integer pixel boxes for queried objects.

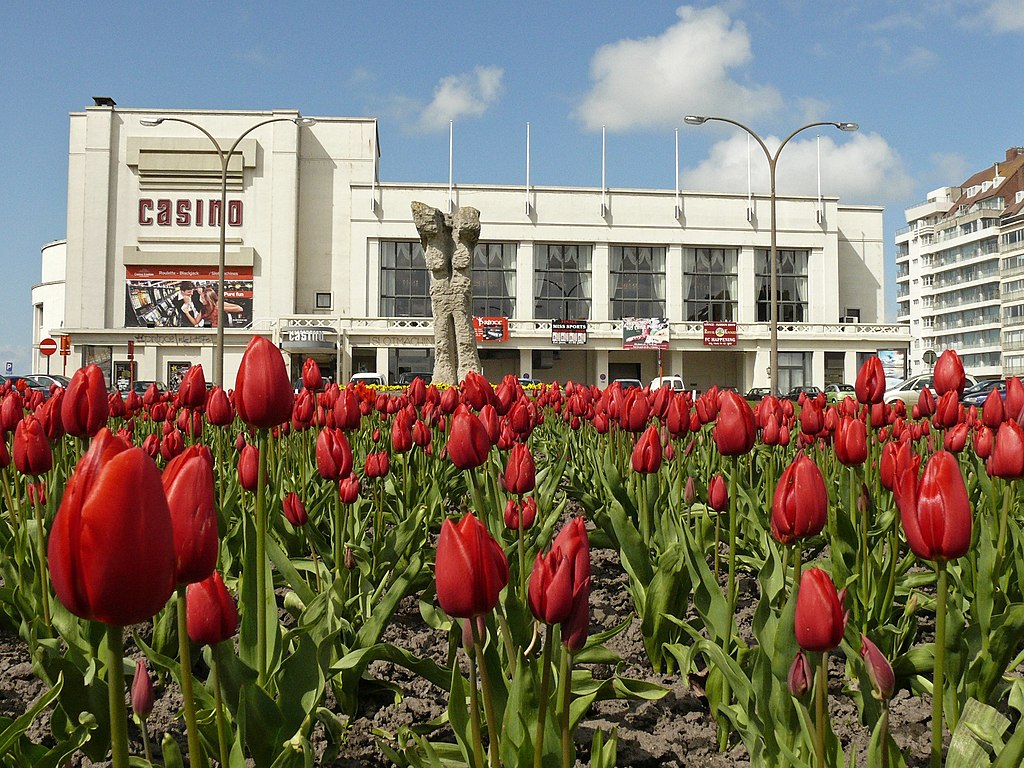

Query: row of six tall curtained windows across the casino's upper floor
[380,241,810,323]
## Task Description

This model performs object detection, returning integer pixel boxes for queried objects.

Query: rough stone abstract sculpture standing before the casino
[412,201,482,385]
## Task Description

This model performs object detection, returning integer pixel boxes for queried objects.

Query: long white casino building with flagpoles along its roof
[33,102,910,391]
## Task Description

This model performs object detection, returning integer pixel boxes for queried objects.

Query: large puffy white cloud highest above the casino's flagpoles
[575,5,781,131]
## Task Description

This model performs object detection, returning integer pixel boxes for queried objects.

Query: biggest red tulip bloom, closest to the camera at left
[47,429,175,627]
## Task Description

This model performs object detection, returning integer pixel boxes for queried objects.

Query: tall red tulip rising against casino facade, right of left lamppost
[234,336,293,429]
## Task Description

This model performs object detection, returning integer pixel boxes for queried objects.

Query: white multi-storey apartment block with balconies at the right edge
[896,147,1024,378]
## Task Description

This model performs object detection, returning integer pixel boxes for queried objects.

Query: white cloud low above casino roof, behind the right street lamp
[683,132,914,205]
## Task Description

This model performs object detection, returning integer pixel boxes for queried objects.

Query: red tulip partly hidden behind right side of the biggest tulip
[162,445,219,584]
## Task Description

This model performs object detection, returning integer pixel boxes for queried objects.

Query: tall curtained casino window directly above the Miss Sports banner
[534,244,594,319]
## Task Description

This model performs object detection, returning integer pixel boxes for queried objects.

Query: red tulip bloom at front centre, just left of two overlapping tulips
[434,514,509,618]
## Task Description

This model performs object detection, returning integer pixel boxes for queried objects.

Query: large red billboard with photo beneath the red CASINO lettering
[125,266,253,328]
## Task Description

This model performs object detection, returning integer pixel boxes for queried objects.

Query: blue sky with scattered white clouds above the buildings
[0,0,1024,371]
